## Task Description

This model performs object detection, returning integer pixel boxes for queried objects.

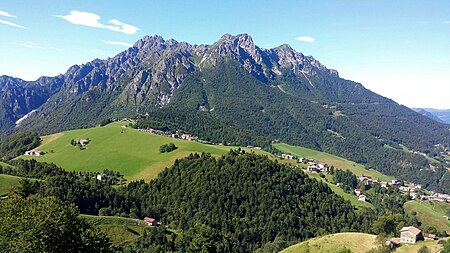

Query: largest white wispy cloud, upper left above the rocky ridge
[56,11,139,34]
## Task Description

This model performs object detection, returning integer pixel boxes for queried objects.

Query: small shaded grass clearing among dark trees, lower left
[81,214,150,245]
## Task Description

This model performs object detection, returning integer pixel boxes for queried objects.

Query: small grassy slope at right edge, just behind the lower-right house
[404,200,450,233]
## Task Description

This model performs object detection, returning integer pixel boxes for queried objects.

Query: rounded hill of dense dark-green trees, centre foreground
[125,151,360,252]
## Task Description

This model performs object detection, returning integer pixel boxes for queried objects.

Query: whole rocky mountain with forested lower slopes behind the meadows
[0,34,450,192]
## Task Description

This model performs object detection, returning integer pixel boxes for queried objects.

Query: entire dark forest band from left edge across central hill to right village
[1,150,432,252]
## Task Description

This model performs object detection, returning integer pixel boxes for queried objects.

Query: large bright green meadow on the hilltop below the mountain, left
[21,122,263,180]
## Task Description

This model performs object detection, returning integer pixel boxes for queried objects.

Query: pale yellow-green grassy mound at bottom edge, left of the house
[281,233,377,253]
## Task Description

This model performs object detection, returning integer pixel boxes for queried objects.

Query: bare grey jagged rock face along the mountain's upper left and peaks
[0,34,372,134]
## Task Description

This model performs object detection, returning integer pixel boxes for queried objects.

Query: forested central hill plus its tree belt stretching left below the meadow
[0,151,358,252]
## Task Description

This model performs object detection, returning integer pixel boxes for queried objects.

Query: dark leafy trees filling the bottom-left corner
[0,195,112,253]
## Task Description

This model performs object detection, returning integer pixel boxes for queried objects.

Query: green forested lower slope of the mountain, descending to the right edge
[135,61,450,192]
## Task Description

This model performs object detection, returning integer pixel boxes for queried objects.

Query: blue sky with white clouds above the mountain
[0,0,450,108]
